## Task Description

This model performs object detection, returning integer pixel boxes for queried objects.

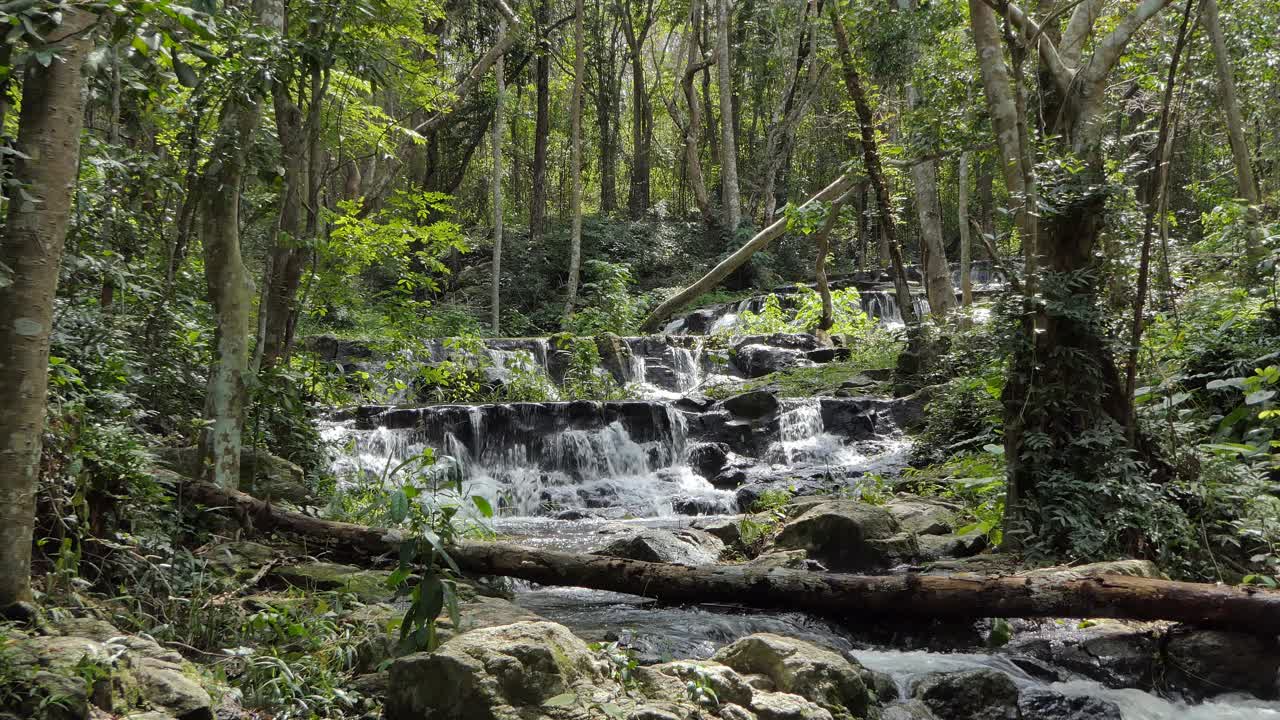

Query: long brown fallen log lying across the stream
[183,483,1280,635]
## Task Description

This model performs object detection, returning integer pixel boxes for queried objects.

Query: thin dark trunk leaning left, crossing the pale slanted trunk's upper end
[831,3,918,325]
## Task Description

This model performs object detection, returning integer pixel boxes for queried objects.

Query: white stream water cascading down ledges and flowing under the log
[323,312,1280,720]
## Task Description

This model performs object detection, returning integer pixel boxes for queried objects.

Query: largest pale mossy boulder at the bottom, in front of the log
[384,623,602,720]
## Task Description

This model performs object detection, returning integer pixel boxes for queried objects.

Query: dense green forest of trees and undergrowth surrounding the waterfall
[0,0,1280,712]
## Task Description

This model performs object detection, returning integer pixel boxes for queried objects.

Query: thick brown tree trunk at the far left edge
[0,9,97,610]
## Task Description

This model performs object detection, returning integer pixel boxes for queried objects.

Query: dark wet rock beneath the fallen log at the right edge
[1165,626,1280,698]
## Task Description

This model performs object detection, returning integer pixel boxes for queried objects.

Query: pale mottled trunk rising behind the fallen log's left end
[198,0,284,488]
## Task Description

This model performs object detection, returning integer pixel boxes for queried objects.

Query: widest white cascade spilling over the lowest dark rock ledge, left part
[325,402,735,516]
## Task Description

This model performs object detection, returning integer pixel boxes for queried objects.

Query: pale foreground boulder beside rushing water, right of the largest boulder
[712,633,870,717]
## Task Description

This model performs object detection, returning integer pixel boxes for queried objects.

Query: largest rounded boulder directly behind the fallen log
[773,500,914,571]
